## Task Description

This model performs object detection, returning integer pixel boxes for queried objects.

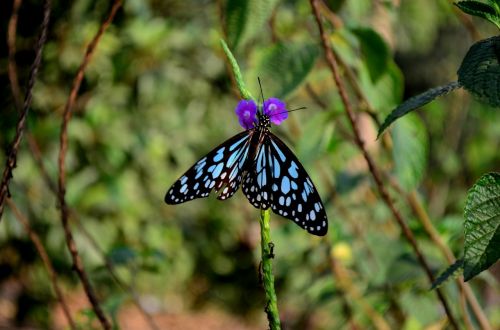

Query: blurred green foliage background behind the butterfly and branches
[0,0,500,329]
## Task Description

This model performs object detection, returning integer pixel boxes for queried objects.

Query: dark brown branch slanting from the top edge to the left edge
[0,0,51,220]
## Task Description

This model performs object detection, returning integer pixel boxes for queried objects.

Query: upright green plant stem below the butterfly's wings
[260,209,281,330]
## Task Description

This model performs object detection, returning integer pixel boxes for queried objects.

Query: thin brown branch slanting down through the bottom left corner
[7,198,76,329]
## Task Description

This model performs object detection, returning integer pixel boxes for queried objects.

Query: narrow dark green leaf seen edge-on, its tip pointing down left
[377,81,461,137]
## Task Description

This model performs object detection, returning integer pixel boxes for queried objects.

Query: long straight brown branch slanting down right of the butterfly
[310,0,459,329]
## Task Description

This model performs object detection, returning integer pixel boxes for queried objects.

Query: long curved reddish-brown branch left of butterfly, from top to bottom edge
[58,0,122,329]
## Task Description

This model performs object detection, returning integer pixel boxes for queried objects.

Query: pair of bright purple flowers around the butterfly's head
[235,97,288,129]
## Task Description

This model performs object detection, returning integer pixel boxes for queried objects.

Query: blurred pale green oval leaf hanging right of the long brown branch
[392,115,429,191]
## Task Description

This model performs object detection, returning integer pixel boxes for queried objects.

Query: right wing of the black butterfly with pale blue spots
[243,132,328,236]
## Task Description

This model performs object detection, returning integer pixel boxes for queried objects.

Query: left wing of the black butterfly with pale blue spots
[165,130,253,204]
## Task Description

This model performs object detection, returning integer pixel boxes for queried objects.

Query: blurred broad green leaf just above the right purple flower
[252,42,319,98]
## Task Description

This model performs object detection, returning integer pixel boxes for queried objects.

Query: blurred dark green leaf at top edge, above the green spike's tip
[226,0,248,48]
